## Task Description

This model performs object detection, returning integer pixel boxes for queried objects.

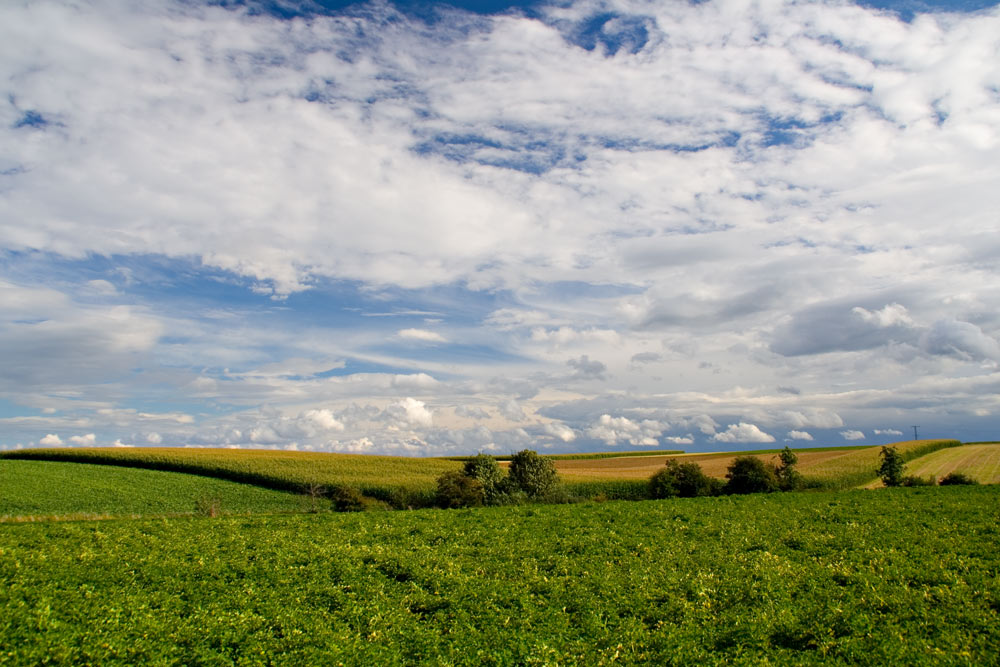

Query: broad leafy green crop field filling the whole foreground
[0,486,1000,665]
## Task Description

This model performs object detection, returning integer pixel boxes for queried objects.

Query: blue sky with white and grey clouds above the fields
[0,0,1000,456]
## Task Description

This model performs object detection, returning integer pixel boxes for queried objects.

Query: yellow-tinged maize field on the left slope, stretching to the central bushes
[4,447,461,505]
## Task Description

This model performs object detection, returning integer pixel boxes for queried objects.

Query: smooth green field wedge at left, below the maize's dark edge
[0,459,312,520]
